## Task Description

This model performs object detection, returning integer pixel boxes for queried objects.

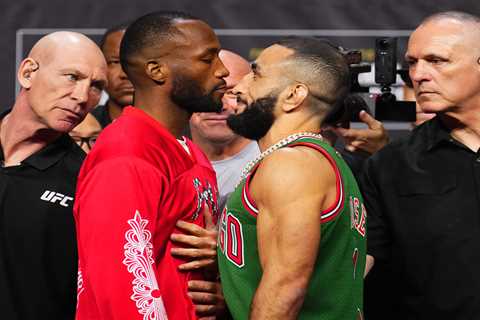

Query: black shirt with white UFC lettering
[0,135,85,320]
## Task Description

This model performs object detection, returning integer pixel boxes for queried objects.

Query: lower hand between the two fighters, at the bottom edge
[188,280,227,320]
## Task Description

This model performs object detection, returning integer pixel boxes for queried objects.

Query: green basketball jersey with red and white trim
[217,136,366,320]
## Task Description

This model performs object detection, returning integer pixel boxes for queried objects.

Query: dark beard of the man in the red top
[170,76,222,113]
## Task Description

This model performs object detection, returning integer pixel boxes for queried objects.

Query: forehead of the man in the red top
[175,20,220,53]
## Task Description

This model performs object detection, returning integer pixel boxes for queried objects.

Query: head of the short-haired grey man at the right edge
[405,11,480,117]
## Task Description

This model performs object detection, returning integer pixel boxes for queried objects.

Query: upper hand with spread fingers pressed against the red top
[170,206,217,271]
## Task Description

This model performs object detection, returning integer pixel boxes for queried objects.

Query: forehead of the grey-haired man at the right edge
[407,20,473,56]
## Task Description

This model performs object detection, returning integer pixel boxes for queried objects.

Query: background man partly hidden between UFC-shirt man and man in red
[91,24,134,128]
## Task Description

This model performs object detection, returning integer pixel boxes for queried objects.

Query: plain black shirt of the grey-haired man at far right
[359,117,480,320]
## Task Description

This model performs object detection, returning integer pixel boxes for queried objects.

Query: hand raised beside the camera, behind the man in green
[333,110,389,154]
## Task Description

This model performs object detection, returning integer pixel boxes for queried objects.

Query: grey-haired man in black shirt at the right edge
[359,12,480,320]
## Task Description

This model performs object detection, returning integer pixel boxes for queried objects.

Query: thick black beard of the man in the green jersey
[227,95,278,141]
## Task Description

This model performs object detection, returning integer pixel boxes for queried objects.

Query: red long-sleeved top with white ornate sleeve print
[74,107,218,320]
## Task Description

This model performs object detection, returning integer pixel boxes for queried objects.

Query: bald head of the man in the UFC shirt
[17,31,107,132]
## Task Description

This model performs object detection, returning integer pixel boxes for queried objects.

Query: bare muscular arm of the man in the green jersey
[250,147,335,320]
